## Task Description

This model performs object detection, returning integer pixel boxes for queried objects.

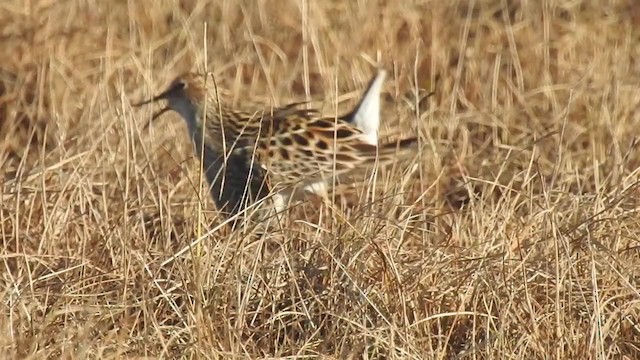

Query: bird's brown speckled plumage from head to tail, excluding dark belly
[137,72,417,217]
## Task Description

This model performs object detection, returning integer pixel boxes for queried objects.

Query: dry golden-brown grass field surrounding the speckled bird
[0,0,640,360]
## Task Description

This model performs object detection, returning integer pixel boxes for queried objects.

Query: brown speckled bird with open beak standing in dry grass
[132,69,419,217]
